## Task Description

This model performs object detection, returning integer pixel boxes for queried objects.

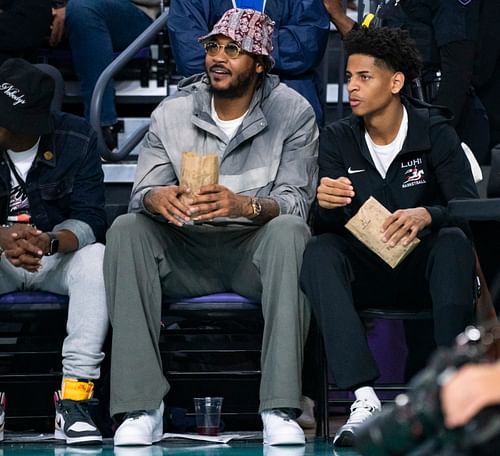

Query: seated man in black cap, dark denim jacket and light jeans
[0,59,108,444]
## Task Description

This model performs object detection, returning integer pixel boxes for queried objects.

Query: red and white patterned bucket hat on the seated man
[198,8,274,71]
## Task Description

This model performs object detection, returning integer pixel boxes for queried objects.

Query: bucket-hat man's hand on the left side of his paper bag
[144,185,191,226]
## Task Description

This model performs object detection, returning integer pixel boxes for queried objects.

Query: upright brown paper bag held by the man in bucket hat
[180,152,219,204]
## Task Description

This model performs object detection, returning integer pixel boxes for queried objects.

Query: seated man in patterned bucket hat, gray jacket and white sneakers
[104,9,318,445]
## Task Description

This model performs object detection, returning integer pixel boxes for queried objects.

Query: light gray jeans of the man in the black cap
[0,244,109,380]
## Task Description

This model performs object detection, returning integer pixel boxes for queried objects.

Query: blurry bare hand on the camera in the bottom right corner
[441,362,500,428]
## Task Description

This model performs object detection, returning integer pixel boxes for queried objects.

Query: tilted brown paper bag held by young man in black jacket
[345,196,420,268]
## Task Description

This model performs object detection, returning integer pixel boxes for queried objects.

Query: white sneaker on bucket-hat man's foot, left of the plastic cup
[114,401,164,446]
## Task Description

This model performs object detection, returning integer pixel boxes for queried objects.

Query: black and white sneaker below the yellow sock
[54,391,102,445]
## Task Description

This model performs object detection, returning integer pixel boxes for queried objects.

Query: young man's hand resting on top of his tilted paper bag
[381,207,432,247]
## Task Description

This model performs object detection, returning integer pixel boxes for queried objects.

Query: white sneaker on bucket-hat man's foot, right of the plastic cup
[260,409,306,445]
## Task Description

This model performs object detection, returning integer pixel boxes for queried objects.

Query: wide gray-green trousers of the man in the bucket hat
[104,214,310,415]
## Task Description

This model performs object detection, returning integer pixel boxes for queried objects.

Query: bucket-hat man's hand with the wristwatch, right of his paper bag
[190,184,253,221]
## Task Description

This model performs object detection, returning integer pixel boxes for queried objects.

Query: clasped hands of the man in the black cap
[5,224,45,272]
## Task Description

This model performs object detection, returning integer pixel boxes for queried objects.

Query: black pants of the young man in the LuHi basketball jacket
[301,228,474,389]
